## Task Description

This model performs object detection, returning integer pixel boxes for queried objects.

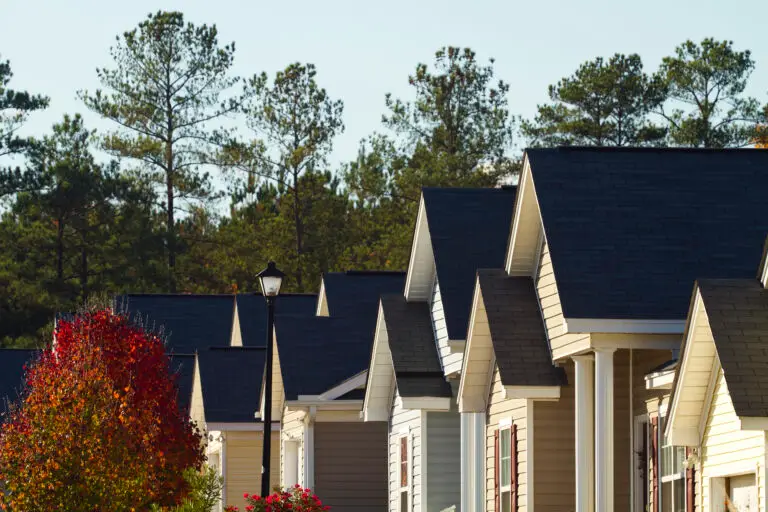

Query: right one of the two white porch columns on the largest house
[595,349,616,512]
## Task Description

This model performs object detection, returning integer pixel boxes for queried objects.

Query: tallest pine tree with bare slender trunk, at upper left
[80,11,242,291]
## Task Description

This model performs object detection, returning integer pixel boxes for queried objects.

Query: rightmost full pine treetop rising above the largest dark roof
[659,38,765,148]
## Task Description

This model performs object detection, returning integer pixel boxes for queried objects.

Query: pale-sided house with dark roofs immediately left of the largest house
[363,187,515,512]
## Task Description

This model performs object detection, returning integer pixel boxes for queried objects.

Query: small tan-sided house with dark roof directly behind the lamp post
[190,347,280,508]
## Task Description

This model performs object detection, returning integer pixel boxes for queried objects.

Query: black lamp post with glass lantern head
[258,261,285,496]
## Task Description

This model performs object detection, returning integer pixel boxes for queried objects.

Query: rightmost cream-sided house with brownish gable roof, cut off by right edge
[654,246,768,512]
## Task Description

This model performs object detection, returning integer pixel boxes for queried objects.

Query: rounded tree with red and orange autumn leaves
[0,309,203,512]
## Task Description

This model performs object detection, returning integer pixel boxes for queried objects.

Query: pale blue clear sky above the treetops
[0,0,768,169]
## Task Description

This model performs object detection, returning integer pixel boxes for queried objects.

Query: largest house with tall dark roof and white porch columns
[459,148,768,512]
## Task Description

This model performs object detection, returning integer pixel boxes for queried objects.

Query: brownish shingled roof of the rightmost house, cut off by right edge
[698,279,768,417]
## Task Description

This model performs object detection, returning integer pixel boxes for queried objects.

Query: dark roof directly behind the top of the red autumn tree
[115,294,235,354]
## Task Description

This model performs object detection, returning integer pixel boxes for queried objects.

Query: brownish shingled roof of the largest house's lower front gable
[477,269,566,386]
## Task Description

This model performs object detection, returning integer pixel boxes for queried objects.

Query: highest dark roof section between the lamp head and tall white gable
[323,270,405,323]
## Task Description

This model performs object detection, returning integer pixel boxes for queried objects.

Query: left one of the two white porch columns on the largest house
[573,355,595,512]
